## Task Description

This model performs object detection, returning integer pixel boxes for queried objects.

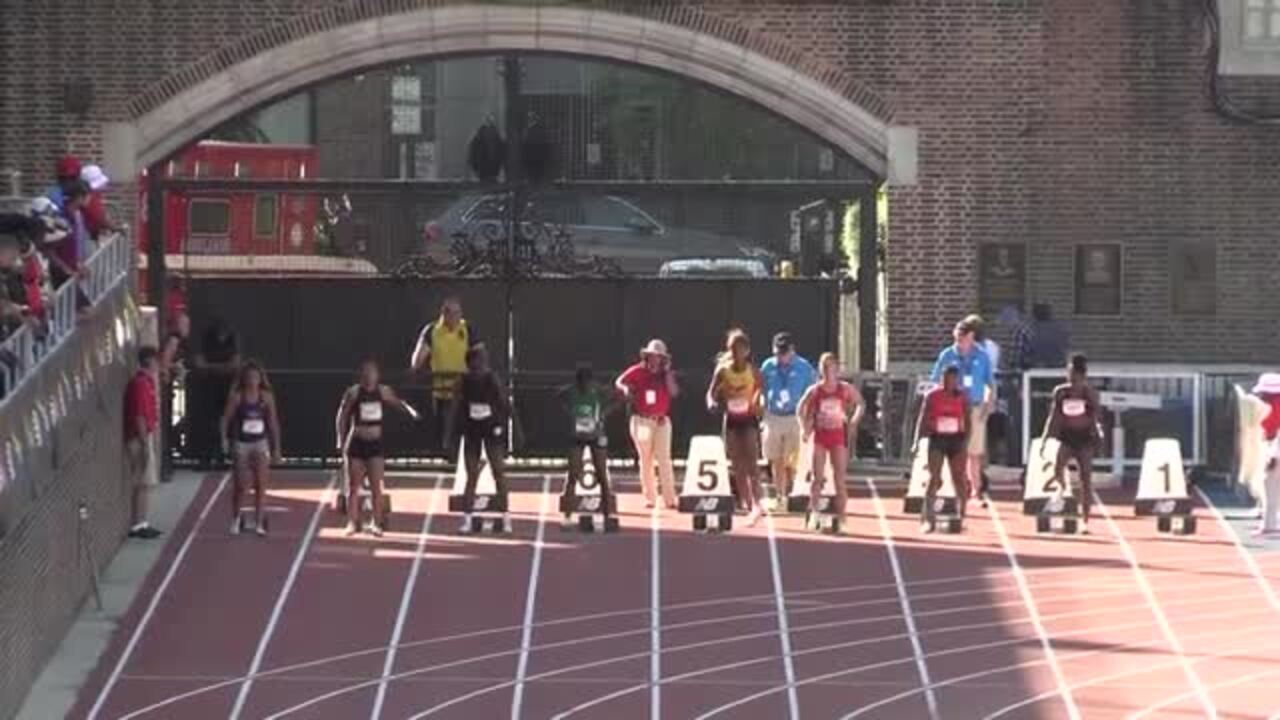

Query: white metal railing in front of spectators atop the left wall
[0,228,134,399]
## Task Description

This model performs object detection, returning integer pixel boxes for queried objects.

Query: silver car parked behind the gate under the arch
[425,192,773,275]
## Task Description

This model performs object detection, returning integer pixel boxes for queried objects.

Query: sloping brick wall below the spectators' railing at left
[0,288,133,717]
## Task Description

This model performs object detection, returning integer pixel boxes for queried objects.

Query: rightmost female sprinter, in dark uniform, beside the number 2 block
[1041,354,1102,534]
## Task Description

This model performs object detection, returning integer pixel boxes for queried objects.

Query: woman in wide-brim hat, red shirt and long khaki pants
[614,340,680,509]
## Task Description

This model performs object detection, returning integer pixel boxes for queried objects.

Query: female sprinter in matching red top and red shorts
[797,352,865,530]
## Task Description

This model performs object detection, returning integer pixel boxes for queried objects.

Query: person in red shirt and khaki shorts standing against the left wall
[124,347,163,539]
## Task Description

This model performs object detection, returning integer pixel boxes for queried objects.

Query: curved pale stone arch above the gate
[129,0,890,178]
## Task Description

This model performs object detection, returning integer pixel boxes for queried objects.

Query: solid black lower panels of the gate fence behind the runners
[174,278,838,461]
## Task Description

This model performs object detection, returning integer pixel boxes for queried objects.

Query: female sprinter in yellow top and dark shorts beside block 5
[707,329,764,527]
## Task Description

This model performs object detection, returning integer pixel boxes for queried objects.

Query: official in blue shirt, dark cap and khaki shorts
[760,332,818,497]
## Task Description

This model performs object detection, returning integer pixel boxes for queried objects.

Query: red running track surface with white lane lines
[72,473,1280,720]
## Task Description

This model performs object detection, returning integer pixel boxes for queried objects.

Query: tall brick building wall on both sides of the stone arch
[0,0,1280,363]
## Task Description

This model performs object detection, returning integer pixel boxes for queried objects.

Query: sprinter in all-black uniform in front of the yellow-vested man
[444,345,511,534]
